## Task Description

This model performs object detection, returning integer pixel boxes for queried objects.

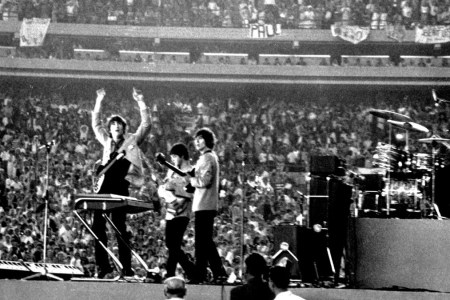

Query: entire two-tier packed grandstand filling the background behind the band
[0,0,450,284]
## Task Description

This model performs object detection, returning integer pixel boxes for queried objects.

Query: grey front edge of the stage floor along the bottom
[0,279,450,300]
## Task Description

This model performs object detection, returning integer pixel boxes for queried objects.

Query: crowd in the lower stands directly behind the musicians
[0,85,448,282]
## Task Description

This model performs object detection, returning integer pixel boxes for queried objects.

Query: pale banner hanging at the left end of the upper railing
[20,18,50,47]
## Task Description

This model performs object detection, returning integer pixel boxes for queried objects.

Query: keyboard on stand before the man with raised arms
[75,194,153,214]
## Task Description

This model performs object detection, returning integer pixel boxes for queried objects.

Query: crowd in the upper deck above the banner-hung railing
[0,0,450,30]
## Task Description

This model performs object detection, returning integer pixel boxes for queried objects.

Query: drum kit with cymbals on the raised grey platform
[369,110,450,217]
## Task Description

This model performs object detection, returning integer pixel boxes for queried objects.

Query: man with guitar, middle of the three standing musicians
[158,143,195,279]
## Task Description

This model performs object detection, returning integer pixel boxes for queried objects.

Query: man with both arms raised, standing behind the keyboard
[92,88,151,278]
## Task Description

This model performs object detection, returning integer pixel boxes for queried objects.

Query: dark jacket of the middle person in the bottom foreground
[230,278,275,300]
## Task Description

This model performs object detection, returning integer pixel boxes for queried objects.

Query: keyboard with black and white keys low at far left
[0,260,84,280]
